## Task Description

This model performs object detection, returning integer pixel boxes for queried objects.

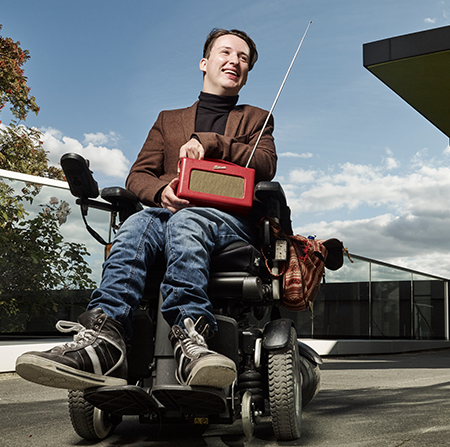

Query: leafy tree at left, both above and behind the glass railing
[0,25,95,332]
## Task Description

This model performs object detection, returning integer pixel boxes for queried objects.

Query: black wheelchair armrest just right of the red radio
[255,181,293,235]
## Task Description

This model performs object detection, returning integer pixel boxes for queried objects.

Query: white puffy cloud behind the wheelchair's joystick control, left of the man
[43,128,130,178]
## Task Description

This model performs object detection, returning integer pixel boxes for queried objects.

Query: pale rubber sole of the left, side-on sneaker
[16,354,127,391]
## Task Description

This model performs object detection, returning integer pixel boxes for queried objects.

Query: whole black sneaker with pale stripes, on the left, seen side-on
[16,308,127,390]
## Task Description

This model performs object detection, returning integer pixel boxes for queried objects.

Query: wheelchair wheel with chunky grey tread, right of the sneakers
[268,328,302,441]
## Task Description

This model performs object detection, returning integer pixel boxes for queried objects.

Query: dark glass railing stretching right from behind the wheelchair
[290,255,449,340]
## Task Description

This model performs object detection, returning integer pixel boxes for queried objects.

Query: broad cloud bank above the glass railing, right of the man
[283,148,450,277]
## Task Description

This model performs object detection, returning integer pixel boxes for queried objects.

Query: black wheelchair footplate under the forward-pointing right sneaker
[152,385,227,415]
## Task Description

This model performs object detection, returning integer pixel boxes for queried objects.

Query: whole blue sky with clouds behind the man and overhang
[0,0,450,277]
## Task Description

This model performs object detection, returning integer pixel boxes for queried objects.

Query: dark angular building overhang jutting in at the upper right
[363,26,450,137]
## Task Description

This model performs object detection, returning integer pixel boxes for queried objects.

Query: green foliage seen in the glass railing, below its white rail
[0,197,95,332]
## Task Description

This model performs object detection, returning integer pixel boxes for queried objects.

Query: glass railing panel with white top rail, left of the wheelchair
[0,171,109,335]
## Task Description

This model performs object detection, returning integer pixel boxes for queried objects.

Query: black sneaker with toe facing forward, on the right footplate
[169,317,236,388]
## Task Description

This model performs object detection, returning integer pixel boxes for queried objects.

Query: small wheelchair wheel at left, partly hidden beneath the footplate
[69,390,120,441]
